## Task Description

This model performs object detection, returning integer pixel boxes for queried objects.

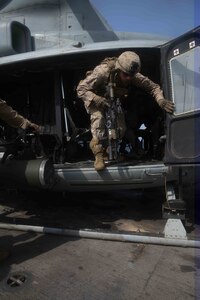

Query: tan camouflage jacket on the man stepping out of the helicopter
[77,58,164,109]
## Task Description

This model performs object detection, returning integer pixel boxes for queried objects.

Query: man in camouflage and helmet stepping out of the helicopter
[77,51,174,171]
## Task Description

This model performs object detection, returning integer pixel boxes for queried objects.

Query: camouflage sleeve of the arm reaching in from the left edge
[0,99,31,129]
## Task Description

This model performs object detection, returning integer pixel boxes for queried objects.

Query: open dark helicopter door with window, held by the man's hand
[161,27,200,165]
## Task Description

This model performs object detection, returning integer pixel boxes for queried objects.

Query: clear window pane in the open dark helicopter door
[170,46,200,115]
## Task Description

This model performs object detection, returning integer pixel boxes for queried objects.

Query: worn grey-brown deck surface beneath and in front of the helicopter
[0,189,200,300]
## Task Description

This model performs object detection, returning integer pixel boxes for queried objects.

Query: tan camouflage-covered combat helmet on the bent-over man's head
[115,51,141,76]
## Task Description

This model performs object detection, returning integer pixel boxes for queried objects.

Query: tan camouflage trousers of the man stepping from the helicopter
[88,109,126,142]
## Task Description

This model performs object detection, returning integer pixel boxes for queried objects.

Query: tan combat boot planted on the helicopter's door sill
[90,139,105,171]
